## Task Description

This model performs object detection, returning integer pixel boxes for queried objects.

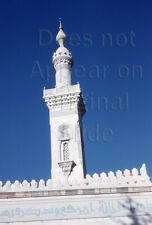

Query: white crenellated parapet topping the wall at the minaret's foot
[0,164,152,192]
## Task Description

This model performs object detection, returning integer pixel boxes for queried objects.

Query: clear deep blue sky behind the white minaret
[0,0,152,182]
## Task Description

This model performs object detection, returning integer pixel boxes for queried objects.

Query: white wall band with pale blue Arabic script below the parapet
[0,189,152,225]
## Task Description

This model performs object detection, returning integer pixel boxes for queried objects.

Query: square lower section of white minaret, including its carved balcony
[44,84,84,182]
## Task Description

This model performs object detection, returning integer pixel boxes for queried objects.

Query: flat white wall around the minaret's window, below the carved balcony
[50,108,84,181]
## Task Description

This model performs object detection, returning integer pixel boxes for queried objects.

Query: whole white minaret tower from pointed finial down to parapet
[43,20,85,182]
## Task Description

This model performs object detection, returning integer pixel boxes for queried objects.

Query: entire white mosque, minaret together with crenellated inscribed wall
[0,21,152,225]
